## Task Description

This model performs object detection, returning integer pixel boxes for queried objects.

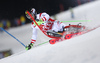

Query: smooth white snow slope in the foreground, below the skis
[0,28,100,63]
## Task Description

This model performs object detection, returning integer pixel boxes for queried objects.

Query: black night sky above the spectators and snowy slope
[0,0,92,20]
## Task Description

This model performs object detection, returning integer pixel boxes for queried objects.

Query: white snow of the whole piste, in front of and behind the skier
[0,1,100,63]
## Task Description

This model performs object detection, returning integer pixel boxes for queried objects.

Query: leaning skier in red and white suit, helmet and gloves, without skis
[25,8,65,50]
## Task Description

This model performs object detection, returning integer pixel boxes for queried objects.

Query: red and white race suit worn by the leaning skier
[31,13,65,43]
